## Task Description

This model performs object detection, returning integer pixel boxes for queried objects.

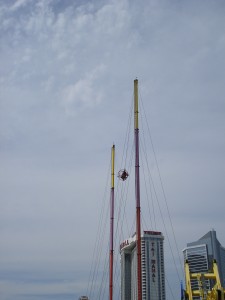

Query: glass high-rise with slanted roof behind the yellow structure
[183,230,225,290]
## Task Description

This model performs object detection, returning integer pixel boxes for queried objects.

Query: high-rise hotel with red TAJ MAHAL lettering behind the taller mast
[120,231,166,300]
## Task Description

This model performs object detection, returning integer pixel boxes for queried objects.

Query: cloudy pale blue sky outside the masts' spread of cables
[0,0,225,300]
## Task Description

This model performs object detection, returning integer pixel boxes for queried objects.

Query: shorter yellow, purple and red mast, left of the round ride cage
[109,145,115,300]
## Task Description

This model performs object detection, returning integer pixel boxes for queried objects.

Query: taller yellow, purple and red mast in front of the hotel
[134,79,142,300]
